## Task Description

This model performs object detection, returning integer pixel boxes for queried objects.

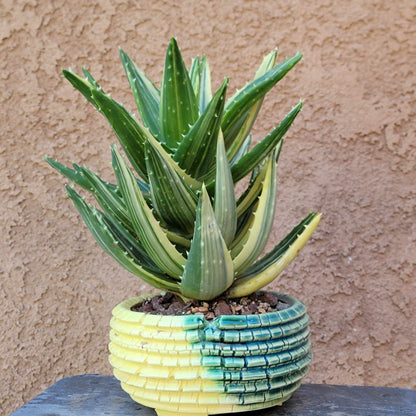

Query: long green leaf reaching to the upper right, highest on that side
[222,53,302,149]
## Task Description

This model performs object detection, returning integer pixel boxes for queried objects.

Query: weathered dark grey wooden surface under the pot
[11,375,416,416]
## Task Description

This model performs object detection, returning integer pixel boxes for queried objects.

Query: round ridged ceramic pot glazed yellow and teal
[109,293,311,416]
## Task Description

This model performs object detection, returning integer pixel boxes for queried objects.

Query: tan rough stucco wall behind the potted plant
[0,0,416,414]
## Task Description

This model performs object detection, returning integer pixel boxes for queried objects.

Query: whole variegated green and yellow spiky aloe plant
[47,39,320,300]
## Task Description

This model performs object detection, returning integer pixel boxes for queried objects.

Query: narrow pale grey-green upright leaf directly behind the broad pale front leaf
[214,134,237,247]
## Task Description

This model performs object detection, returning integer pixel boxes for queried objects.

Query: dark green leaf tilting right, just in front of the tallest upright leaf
[173,79,228,180]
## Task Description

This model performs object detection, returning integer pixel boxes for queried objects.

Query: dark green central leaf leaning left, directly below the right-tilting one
[145,142,198,235]
